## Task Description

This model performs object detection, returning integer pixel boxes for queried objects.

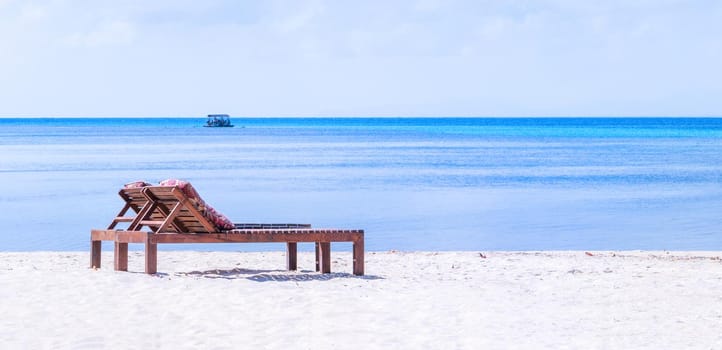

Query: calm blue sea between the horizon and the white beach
[0,118,722,251]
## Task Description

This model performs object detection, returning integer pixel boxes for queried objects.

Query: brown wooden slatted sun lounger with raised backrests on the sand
[90,186,364,275]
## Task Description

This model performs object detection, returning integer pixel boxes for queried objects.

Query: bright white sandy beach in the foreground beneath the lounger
[0,251,722,349]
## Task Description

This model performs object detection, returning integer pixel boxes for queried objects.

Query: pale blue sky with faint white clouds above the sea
[0,0,722,117]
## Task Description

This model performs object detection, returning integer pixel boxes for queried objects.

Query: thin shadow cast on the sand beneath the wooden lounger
[175,268,383,282]
